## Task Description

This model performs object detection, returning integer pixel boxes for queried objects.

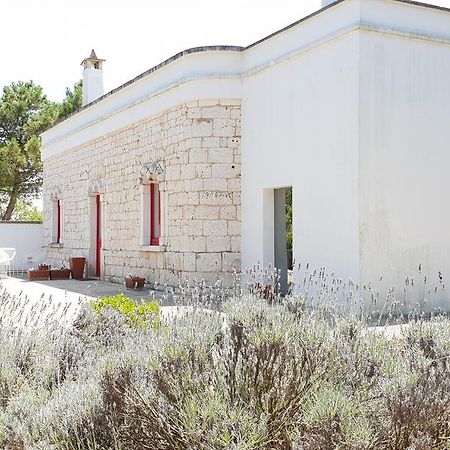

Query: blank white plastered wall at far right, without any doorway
[359,12,450,310]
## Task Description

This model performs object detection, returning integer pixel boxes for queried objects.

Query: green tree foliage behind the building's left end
[0,81,81,220]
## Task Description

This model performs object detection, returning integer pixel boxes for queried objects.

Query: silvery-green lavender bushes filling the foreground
[0,272,450,450]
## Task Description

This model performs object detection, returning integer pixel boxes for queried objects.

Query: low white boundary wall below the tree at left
[0,221,43,270]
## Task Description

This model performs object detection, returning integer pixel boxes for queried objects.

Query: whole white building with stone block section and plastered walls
[42,0,450,308]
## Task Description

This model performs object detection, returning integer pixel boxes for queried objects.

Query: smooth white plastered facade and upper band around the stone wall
[43,0,450,308]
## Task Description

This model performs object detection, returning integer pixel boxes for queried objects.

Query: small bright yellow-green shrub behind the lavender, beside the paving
[91,294,161,330]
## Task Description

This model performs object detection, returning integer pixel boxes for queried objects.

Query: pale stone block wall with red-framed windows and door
[44,99,241,285]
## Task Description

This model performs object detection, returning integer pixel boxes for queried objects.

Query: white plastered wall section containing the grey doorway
[242,32,359,279]
